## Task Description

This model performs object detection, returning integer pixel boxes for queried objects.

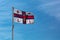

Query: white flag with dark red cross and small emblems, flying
[14,9,34,24]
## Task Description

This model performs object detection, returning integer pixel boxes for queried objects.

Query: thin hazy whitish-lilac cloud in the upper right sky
[38,1,60,20]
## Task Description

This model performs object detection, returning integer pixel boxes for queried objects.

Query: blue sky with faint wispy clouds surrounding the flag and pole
[0,0,60,40]
